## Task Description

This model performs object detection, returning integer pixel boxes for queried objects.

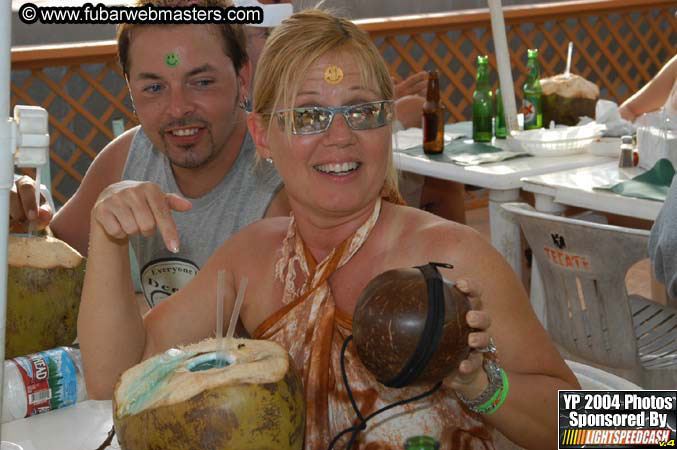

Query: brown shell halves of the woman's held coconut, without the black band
[353,268,472,385]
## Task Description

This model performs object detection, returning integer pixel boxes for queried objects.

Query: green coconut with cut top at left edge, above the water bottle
[5,235,85,359]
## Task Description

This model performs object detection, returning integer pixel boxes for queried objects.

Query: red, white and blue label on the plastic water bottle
[12,347,78,417]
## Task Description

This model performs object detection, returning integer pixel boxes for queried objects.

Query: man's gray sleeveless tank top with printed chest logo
[122,127,282,308]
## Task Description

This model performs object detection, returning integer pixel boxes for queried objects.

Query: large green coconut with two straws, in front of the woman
[113,339,305,450]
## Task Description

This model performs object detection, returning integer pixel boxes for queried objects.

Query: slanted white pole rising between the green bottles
[488,0,518,131]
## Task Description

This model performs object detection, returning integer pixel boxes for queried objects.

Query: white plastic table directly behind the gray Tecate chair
[522,160,663,326]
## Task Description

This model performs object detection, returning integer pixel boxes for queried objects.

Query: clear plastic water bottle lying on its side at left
[2,347,87,423]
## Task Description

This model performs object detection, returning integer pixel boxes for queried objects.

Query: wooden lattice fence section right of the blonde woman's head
[358,0,677,121]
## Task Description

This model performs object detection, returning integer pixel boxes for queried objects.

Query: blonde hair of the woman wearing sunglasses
[253,9,401,202]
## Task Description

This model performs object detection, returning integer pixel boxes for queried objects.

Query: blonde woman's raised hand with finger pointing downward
[92,181,192,253]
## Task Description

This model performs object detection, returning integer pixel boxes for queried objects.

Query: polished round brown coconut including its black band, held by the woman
[353,263,472,387]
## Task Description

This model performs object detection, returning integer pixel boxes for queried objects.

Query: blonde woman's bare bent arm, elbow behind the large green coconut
[78,202,237,399]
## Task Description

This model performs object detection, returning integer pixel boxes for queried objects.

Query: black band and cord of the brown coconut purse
[327,262,454,450]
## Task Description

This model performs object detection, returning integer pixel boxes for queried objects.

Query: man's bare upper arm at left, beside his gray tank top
[50,128,137,256]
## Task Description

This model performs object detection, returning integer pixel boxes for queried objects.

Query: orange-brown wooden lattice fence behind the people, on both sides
[11,0,677,204]
